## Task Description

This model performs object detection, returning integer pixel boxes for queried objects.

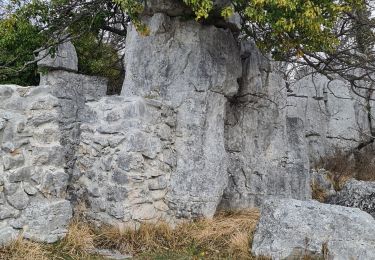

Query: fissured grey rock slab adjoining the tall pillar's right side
[221,44,311,209]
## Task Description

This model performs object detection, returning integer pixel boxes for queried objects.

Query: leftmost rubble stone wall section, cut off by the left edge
[0,85,72,244]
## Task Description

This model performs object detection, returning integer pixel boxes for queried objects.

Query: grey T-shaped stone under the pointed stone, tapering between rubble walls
[40,70,107,182]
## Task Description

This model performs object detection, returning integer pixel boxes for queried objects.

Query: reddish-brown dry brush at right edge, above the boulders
[313,150,375,191]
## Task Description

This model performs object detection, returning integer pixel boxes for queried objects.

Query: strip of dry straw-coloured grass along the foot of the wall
[0,209,266,260]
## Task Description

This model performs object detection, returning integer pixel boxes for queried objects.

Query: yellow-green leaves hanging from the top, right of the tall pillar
[180,0,362,59]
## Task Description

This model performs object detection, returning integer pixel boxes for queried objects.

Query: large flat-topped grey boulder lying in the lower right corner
[252,198,375,260]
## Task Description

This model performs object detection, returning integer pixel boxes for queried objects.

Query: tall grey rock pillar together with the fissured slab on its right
[122,13,311,217]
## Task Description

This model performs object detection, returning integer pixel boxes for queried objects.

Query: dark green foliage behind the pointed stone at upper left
[0,0,126,88]
